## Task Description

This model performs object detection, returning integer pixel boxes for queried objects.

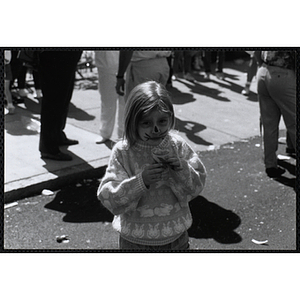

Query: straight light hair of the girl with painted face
[124,81,175,147]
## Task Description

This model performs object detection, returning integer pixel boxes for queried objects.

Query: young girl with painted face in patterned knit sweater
[97,81,206,250]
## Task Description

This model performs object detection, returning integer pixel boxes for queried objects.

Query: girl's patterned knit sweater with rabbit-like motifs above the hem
[97,133,206,245]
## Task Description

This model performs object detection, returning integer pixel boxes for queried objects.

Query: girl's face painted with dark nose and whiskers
[138,109,171,146]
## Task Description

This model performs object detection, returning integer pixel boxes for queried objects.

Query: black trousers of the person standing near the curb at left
[38,51,82,154]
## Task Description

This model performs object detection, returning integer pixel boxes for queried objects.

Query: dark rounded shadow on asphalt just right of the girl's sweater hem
[188,196,242,244]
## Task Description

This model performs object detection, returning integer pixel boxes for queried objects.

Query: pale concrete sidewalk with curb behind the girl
[4,58,284,202]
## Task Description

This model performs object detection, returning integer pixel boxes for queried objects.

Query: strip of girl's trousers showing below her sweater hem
[119,231,189,251]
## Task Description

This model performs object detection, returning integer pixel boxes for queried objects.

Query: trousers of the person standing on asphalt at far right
[257,64,296,168]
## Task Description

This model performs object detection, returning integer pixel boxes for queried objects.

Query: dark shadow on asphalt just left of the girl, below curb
[45,179,113,223]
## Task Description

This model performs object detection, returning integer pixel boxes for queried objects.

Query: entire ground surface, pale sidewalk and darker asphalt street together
[4,55,296,251]
